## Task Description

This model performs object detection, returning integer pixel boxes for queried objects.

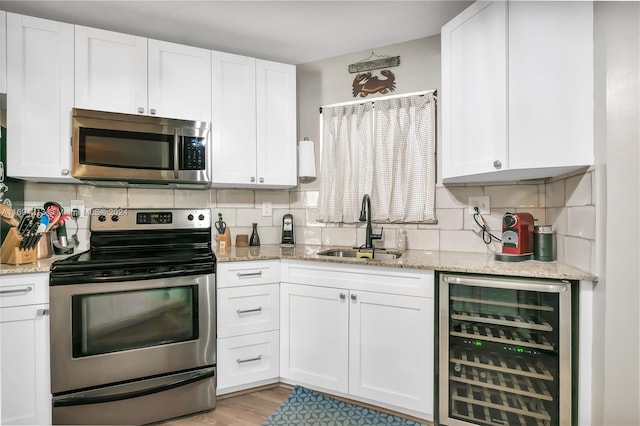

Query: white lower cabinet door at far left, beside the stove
[0,304,51,425]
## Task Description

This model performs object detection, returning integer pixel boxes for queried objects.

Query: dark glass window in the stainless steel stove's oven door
[71,285,199,358]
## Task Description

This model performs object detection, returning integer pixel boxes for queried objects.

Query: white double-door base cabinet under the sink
[280,260,434,420]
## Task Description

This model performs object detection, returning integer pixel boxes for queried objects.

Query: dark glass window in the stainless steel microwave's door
[79,127,174,170]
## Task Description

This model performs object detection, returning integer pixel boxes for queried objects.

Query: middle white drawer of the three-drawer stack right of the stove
[218,284,280,337]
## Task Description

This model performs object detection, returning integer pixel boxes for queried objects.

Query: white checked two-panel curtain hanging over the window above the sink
[317,92,436,223]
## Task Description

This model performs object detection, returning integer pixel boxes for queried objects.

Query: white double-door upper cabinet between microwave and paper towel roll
[211,52,297,189]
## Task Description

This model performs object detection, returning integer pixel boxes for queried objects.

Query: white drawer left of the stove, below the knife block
[0,274,49,308]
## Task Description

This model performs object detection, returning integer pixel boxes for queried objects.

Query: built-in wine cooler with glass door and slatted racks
[438,274,572,426]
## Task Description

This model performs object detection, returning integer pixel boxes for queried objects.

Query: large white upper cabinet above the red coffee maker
[440,1,593,183]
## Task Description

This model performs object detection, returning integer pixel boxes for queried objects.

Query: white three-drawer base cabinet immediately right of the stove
[216,260,280,395]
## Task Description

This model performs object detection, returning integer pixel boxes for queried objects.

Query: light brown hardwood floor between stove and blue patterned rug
[159,385,292,426]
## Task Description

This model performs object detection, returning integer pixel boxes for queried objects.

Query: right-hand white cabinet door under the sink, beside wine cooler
[349,291,434,415]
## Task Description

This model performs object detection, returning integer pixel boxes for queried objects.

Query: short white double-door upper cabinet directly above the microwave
[75,26,211,122]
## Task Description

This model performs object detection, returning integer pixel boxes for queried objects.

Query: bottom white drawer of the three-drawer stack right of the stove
[218,331,280,389]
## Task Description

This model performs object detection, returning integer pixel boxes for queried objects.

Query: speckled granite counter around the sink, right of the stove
[216,245,598,281]
